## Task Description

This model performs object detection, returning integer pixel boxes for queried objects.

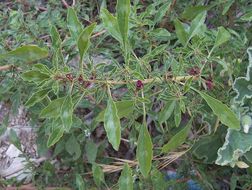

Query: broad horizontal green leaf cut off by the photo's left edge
[0,45,48,63]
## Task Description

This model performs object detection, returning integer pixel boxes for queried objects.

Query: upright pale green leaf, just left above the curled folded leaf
[67,8,83,40]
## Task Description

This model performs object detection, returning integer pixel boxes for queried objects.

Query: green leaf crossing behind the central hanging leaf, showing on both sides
[95,100,134,122]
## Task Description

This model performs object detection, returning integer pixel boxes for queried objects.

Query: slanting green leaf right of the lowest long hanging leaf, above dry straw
[162,121,191,153]
